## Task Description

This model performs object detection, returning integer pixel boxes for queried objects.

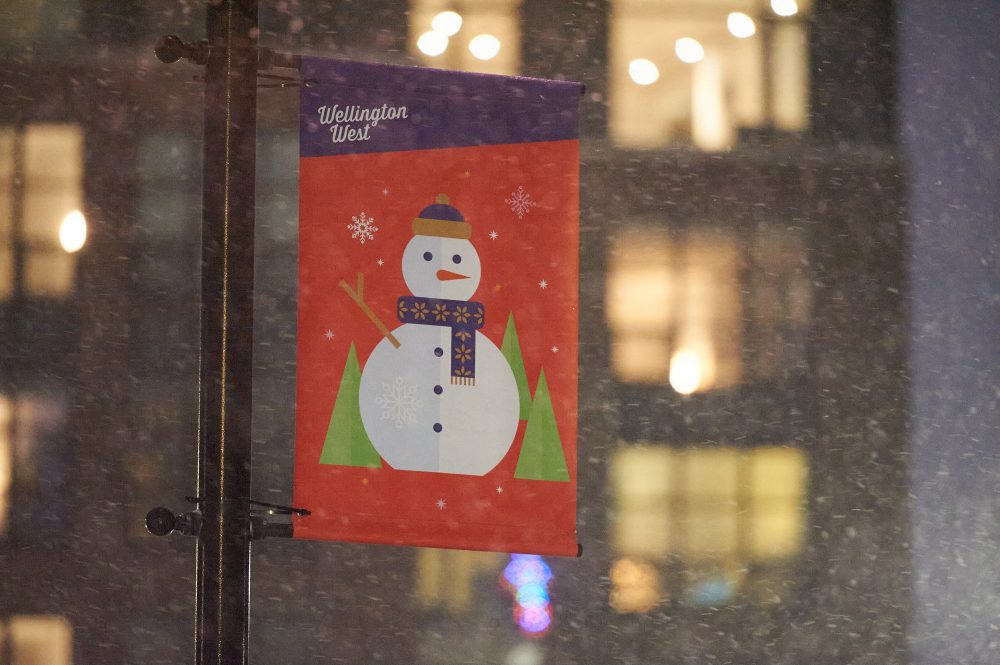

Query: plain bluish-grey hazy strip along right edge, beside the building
[899,0,1000,665]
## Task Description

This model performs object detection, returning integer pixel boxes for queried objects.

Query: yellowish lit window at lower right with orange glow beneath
[610,445,807,612]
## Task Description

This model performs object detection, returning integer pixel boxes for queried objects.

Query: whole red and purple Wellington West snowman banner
[294,58,582,556]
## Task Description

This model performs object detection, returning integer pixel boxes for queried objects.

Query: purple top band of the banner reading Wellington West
[299,57,583,157]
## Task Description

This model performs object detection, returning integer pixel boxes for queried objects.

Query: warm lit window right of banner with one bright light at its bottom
[607,225,742,394]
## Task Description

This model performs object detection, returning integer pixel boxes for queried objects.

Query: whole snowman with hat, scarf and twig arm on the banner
[341,194,519,476]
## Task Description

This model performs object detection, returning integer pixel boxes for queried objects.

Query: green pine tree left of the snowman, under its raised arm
[319,342,382,468]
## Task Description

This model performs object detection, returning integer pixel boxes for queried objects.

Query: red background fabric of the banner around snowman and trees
[294,140,579,555]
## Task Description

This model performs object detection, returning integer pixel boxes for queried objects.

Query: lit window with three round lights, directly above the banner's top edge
[409,0,521,74]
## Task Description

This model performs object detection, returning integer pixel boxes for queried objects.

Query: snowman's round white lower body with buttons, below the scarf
[359,323,519,476]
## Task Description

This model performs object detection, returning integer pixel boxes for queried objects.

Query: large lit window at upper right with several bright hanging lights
[609,0,810,151]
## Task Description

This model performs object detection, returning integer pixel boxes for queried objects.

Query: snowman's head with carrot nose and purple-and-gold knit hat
[403,194,482,300]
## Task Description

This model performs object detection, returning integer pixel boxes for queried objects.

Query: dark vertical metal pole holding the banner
[196,0,258,665]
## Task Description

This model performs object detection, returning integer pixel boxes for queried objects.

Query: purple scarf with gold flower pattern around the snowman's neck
[396,296,486,386]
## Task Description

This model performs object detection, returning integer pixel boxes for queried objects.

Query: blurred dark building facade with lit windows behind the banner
[0,0,911,664]
